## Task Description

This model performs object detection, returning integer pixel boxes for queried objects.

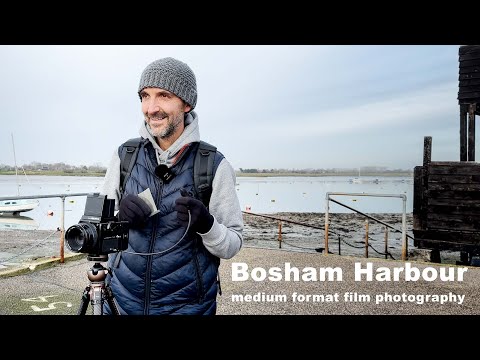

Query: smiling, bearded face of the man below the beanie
[140,88,191,140]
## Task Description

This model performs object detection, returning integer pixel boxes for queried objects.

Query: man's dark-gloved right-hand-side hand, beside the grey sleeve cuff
[175,189,213,234]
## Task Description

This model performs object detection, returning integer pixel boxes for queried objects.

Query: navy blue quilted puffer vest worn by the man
[105,143,223,315]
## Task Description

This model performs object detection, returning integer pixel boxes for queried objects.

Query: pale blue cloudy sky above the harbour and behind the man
[0,45,466,170]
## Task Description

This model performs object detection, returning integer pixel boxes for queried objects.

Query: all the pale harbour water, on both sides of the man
[0,175,413,230]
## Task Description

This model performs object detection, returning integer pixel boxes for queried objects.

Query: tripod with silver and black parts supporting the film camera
[77,255,120,315]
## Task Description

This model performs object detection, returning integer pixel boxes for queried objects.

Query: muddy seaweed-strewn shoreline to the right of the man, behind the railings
[243,212,460,264]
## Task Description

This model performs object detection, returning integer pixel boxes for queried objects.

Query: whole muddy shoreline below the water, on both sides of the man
[0,212,460,267]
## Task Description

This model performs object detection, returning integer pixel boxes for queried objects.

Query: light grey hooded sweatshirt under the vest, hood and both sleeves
[102,111,243,259]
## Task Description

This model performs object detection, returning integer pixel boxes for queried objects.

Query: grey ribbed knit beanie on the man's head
[138,57,197,110]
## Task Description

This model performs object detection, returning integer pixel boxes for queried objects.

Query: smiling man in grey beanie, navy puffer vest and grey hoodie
[103,58,243,315]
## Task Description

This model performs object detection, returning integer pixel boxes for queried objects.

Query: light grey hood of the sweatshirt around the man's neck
[139,111,200,167]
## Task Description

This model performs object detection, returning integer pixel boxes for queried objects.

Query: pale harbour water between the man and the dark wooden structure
[236,176,413,213]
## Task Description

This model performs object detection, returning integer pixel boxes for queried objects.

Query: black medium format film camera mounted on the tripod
[65,193,128,256]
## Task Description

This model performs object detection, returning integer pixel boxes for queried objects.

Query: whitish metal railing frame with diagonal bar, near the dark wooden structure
[325,192,406,260]
